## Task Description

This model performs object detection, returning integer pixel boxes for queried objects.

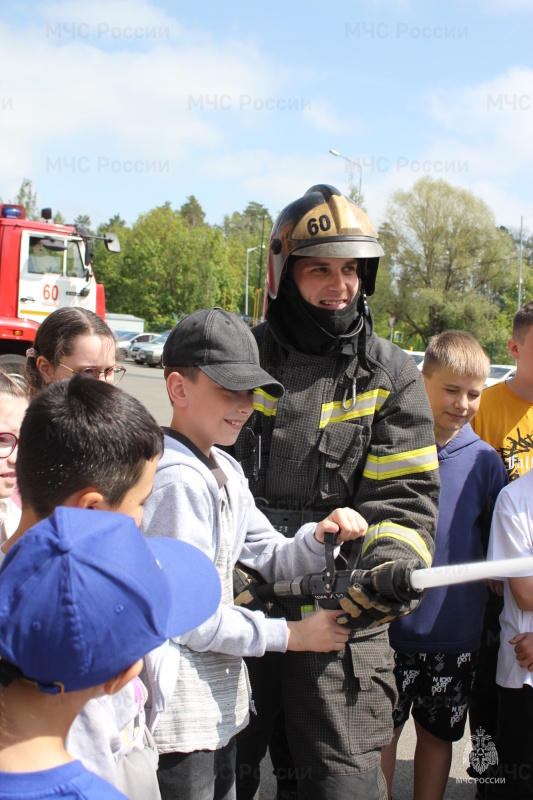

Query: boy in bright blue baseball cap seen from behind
[0,508,220,800]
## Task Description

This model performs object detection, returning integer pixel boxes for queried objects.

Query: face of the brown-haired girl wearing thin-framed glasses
[37,334,116,383]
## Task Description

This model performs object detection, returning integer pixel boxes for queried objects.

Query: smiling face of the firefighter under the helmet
[293,256,359,311]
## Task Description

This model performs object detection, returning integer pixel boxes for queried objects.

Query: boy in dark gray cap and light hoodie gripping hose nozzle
[139,309,366,800]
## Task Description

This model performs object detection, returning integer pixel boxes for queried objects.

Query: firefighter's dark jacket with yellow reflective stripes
[235,325,440,569]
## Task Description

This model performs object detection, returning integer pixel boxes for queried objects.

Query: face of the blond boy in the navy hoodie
[424,367,485,446]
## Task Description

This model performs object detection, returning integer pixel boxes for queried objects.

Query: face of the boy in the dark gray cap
[179,371,254,456]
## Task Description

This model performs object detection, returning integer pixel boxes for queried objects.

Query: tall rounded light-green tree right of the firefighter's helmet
[378,177,516,357]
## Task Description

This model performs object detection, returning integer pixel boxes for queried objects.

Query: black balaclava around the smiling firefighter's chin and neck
[266,259,370,362]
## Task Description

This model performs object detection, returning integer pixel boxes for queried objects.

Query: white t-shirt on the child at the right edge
[487,471,533,689]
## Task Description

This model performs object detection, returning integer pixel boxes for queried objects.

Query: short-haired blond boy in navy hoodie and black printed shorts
[382,331,507,800]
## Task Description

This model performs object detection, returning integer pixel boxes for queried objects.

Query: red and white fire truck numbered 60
[0,204,120,372]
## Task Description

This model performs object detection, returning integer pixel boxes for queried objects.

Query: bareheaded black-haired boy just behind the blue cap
[0,377,163,800]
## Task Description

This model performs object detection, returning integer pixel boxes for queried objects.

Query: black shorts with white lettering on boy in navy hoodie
[394,653,477,742]
